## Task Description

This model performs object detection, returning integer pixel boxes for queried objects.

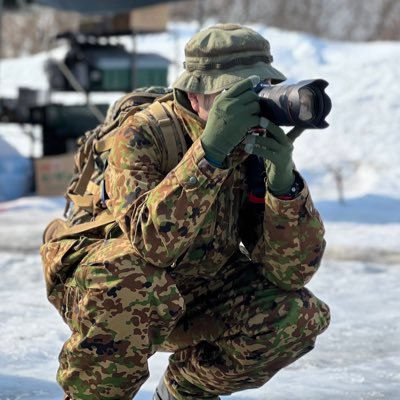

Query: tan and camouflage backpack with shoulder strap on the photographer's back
[43,87,187,243]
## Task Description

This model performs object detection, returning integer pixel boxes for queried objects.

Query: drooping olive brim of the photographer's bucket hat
[172,62,286,94]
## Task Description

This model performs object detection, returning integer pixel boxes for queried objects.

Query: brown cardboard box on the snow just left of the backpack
[34,154,74,196]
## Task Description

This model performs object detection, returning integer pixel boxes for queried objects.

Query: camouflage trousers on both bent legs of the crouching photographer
[57,239,329,400]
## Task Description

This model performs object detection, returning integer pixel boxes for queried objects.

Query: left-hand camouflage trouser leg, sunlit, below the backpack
[57,238,184,400]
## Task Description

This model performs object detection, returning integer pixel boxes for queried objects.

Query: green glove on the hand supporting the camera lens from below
[245,118,295,196]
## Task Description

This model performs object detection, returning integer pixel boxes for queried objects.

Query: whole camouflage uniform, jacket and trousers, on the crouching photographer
[45,23,329,400]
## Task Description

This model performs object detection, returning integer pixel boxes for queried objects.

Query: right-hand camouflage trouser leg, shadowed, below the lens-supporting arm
[164,254,330,400]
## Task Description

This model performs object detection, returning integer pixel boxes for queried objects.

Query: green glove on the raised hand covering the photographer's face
[200,77,260,168]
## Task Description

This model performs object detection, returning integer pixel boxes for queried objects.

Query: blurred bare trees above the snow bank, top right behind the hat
[172,0,400,40]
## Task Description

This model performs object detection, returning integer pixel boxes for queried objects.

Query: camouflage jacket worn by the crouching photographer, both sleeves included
[105,97,325,290]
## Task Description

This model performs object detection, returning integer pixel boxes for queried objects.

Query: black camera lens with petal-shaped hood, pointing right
[254,79,332,129]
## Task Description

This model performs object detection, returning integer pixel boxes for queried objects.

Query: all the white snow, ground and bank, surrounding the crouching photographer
[0,23,400,400]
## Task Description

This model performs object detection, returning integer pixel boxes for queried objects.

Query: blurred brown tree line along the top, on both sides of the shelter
[1,0,400,57]
